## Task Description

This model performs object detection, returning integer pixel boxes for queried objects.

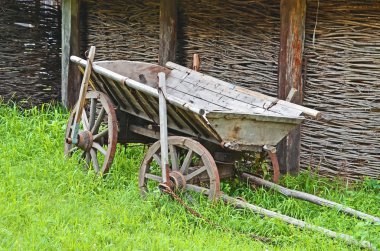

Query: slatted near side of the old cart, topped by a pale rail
[70,56,222,145]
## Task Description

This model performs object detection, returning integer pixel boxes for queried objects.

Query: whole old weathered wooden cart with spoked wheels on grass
[65,56,320,199]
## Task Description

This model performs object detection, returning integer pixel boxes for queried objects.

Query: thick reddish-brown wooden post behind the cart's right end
[277,0,306,174]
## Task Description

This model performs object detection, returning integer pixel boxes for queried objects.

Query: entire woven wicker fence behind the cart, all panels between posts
[0,0,380,179]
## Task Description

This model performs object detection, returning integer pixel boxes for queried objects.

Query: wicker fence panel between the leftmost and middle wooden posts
[80,0,160,63]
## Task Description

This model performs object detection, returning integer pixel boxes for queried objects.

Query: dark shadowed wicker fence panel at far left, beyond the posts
[0,0,61,106]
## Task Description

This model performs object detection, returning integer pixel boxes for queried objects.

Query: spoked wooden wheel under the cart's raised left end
[65,91,117,174]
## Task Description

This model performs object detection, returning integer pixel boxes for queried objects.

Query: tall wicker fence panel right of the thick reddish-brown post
[302,0,380,178]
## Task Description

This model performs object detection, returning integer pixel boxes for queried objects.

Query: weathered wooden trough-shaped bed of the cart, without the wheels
[71,56,314,150]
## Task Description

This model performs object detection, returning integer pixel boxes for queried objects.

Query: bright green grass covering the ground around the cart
[0,104,380,250]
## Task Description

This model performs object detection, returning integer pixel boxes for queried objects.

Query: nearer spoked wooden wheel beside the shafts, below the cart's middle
[139,136,220,201]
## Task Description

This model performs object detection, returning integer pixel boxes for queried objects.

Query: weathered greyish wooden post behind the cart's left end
[61,0,80,108]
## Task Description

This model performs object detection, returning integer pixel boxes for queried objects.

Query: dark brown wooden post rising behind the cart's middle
[158,0,177,66]
